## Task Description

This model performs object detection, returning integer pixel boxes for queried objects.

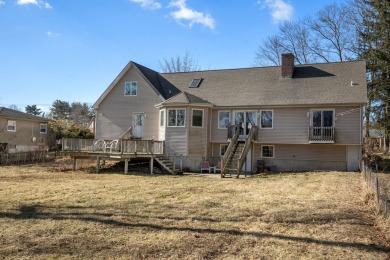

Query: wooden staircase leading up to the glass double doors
[221,126,257,178]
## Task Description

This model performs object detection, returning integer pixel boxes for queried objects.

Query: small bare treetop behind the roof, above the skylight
[159,51,200,73]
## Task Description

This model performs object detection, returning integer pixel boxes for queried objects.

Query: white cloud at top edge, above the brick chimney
[257,0,294,23]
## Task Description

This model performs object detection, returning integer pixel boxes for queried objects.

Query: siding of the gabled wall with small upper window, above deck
[96,67,161,139]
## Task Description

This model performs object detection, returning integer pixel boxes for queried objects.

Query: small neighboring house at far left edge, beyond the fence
[0,107,50,153]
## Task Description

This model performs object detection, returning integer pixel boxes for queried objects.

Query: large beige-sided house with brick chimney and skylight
[93,54,367,171]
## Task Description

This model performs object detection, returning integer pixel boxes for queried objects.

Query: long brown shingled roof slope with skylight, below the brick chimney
[160,61,367,107]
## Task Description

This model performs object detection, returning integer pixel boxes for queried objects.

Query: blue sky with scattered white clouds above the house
[0,0,339,111]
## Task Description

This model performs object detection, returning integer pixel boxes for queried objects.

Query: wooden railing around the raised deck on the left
[62,138,164,154]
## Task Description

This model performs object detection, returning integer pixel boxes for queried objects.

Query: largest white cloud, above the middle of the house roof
[169,0,215,30]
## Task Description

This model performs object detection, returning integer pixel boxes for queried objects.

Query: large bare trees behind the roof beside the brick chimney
[255,4,357,66]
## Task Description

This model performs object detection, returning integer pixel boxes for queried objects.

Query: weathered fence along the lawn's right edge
[362,163,390,218]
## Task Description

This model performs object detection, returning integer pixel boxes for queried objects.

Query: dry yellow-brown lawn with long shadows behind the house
[0,161,390,259]
